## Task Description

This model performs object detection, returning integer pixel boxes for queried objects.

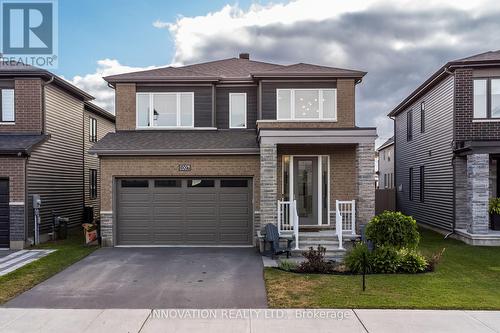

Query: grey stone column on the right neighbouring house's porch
[467,154,490,234]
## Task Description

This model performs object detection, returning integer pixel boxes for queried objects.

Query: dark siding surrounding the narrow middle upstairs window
[215,86,257,129]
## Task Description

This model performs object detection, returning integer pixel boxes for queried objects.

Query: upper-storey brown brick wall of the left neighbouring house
[0,78,42,133]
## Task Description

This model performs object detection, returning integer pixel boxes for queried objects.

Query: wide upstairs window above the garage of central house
[136,92,194,128]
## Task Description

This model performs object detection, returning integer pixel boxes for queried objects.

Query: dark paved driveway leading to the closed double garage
[5,248,267,309]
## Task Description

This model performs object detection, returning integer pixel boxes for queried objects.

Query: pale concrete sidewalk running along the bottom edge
[0,308,500,333]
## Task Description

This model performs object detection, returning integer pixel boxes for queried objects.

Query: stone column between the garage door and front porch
[260,144,278,227]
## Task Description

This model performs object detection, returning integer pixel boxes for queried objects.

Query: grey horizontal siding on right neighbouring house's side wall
[395,76,454,231]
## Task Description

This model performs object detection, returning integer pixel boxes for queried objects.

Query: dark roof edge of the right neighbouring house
[388,50,500,117]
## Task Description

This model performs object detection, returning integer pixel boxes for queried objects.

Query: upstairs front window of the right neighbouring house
[473,79,500,119]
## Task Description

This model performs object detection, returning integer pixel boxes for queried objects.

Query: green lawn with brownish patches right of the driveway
[264,230,500,310]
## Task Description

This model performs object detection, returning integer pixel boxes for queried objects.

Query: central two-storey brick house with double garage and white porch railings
[91,54,376,246]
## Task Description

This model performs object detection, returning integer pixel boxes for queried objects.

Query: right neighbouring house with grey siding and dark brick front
[389,51,500,245]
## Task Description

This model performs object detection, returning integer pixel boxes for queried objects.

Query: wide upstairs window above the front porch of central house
[276,89,337,121]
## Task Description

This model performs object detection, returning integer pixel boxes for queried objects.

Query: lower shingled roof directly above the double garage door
[91,130,259,155]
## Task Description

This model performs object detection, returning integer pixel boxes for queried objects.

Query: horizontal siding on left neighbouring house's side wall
[27,85,84,236]
